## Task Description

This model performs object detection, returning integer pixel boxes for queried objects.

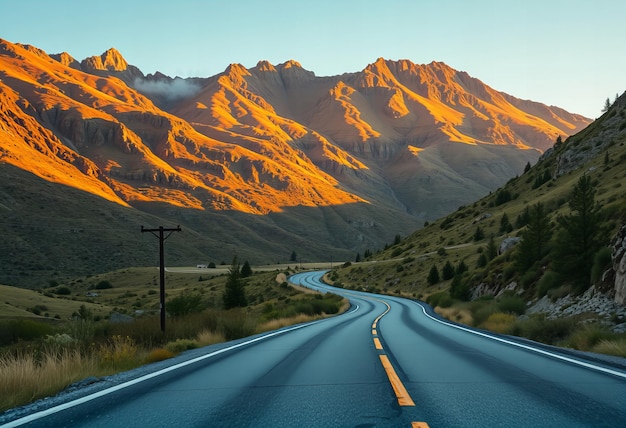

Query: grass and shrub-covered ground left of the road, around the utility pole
[0,259,348,411]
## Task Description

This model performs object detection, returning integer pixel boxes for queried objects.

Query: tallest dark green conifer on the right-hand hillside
[555,175,602,291]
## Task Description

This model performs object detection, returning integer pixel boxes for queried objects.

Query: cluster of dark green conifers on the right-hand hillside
[427,176,610,299]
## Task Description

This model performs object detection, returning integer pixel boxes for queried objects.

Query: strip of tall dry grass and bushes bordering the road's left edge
[0,295,348,411]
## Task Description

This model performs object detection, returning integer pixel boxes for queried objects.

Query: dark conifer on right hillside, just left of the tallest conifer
[516,202,552,271]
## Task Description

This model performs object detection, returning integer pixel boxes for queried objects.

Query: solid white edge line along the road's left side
[2,305,359,428]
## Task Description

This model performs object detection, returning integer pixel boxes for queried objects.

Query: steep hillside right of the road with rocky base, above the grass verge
[336,89,626,304]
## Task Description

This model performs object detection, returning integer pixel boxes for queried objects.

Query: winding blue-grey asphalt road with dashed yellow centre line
[7,272,626,428]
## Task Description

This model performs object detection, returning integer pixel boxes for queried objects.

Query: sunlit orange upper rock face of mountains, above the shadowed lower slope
[0,41,590,225]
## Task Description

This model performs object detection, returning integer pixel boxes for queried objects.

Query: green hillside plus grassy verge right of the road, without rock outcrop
[332,100,626,357]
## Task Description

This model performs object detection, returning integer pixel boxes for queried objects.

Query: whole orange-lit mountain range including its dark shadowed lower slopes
[0,40,590,286]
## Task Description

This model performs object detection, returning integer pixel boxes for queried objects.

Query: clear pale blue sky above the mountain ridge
[0,0,626,118]
